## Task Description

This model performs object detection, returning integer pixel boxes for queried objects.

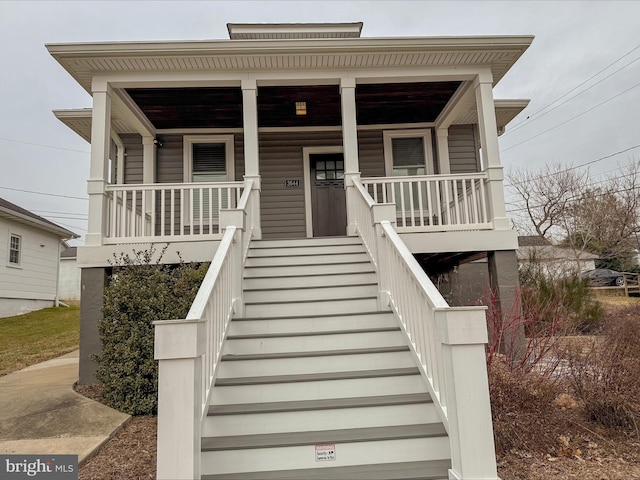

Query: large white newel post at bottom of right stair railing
[435,307,499,480]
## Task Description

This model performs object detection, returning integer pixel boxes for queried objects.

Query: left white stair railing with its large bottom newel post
[155,180,259,480]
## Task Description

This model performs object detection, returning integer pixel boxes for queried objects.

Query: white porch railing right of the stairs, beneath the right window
[362,173,492,233]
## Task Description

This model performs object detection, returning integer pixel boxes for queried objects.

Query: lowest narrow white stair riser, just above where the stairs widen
[244,295,378,318]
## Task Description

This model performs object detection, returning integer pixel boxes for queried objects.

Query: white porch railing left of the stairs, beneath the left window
[104,182,243,244]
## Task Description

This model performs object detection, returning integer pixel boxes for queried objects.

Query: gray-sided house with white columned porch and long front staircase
[47,23,532,479]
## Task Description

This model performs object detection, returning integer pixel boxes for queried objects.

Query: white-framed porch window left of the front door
[184,135,235,220]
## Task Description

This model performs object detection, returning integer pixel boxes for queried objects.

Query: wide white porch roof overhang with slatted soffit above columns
[46,36,533,93]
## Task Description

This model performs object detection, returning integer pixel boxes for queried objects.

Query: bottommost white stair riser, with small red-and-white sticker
[201,438,450,480]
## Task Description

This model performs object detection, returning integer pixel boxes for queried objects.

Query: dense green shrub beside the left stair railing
[95,247,208,415]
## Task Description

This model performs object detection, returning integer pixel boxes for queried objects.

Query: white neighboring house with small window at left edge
[0,198,77,317]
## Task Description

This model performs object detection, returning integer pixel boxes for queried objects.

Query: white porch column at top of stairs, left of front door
[241,79,262,239]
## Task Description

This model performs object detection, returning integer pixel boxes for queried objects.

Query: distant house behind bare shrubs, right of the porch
[517,235,598,278]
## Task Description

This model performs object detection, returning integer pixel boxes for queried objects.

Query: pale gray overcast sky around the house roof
[0,0,640,244]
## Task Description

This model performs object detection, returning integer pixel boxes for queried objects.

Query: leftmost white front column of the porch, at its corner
[85,82,111,246]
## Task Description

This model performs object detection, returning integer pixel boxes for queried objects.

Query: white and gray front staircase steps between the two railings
[201,237,450,480]
